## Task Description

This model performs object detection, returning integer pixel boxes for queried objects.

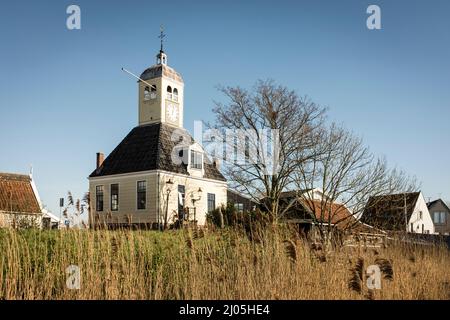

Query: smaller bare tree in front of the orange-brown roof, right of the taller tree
[286,124,416,239]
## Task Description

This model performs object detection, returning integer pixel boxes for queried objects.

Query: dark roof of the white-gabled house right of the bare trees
[360,192,420,230]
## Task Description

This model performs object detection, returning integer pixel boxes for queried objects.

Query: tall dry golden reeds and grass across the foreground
[0,225,450,299]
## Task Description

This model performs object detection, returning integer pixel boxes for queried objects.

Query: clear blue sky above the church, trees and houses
[0,0,450,212]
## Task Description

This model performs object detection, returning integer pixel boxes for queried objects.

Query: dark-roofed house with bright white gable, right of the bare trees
[360,192,435,234]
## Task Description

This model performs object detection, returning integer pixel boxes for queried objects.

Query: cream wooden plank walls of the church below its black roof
[89,170,227,225]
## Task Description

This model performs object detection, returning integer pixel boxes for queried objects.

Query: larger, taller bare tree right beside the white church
[210,80,325,218]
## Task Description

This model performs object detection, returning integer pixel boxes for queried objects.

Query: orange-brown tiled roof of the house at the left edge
[0,173,41,213]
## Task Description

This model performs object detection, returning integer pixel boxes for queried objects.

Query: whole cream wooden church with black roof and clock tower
[89,41,227,228]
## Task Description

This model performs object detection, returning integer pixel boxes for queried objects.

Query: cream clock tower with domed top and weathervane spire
[138,32,184,128]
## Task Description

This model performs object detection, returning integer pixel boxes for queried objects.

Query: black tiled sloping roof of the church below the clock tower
[89,123,226,181]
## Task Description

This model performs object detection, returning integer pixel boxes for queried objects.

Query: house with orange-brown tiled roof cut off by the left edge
[0,173,43,228]
